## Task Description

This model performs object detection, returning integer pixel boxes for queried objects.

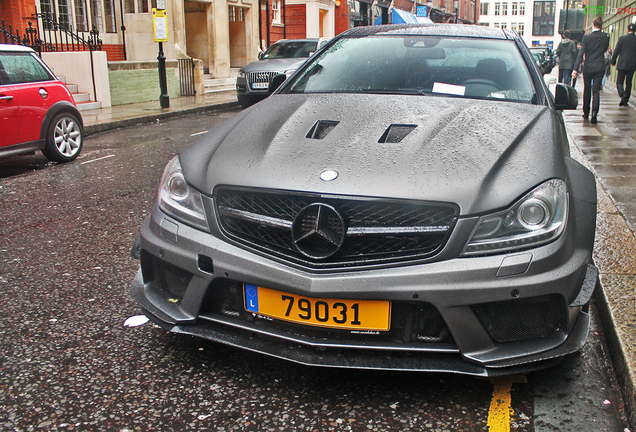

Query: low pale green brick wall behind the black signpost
[108,61,180,106]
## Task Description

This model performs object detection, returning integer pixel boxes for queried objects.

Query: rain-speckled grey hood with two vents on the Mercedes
[180,94,568,215]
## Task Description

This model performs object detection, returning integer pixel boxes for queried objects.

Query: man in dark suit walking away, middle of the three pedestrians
[572,17,609,123]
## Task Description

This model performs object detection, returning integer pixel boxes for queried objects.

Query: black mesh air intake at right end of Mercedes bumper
[472,295,567,343]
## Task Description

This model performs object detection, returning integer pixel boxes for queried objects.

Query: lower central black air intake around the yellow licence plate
[199,279,456,349]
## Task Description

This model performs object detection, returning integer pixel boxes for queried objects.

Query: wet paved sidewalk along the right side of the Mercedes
[563,78,636,426]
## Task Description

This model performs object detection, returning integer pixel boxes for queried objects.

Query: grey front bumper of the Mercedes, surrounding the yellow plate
[131,187,598,376]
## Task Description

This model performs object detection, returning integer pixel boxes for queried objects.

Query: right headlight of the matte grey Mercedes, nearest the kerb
[462,179,568,256]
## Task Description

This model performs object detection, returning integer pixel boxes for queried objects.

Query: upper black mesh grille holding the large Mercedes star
[215,188,457,268]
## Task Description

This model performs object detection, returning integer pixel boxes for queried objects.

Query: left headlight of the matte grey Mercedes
[157,156,210,232]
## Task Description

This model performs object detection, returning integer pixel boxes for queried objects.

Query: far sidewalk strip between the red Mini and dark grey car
[81,90,239,136]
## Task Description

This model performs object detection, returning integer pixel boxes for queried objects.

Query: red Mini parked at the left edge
[0,44,84,162]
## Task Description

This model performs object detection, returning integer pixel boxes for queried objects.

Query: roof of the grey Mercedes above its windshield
[347,23,519,39]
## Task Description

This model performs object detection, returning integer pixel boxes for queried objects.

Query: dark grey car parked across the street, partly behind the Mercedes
[236,38,328,107]
